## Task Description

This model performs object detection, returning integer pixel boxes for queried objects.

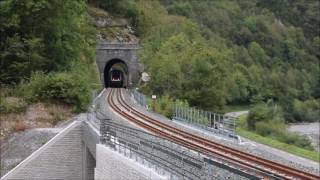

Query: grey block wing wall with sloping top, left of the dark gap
[1,121,83,180]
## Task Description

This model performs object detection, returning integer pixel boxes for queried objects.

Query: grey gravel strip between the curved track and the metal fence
[122,91,320,174]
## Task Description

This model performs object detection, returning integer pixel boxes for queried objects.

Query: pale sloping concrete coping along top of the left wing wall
[0,121,82,180]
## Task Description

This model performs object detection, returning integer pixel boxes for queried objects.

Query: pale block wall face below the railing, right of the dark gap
[95,144,166,180]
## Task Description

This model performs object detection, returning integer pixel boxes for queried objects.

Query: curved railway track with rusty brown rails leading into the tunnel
[107,89,320,180]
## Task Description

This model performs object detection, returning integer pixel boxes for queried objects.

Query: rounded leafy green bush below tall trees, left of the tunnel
[19,69,90,111]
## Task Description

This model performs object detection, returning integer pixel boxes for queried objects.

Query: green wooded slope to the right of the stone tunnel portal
[91,0,320,122]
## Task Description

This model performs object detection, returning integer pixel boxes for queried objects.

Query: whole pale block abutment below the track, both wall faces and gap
[1,118,167,180]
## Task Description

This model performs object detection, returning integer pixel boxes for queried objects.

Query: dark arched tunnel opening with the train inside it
[104,59,128,88]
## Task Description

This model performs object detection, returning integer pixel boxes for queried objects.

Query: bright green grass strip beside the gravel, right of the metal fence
[236,115,320,162]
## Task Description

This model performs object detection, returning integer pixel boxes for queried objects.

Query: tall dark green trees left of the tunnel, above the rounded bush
[0,0,95,84]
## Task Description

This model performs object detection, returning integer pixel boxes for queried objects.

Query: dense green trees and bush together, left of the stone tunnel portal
[0,0,97,111]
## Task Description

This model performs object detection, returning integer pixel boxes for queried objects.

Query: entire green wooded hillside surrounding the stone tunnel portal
[0,0,320,155]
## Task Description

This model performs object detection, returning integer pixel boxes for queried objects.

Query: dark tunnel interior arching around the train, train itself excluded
[104,58,129,88]
